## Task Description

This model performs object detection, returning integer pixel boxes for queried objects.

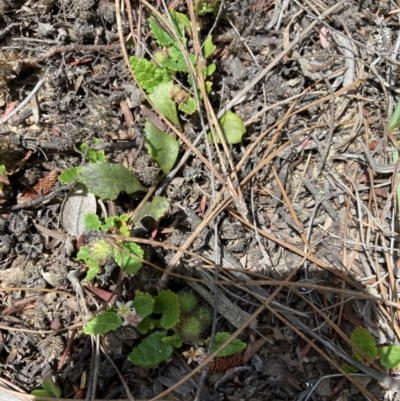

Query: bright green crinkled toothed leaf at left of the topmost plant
[129,56,170,93]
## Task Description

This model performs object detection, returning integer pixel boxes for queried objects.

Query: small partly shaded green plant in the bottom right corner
[342,327,400,373]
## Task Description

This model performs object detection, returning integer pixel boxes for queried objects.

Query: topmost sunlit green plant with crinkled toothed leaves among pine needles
[130,9,246,145]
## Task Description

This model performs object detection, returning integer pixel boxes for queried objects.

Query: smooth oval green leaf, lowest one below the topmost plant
[144,120,179,174]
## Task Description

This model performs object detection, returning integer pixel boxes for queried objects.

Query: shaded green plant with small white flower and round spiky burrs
[83,290,246,367]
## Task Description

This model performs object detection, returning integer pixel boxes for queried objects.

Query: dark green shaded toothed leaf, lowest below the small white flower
[128,332,174,368]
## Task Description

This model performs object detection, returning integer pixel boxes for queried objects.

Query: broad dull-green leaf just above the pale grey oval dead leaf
[78,162,146,200]
